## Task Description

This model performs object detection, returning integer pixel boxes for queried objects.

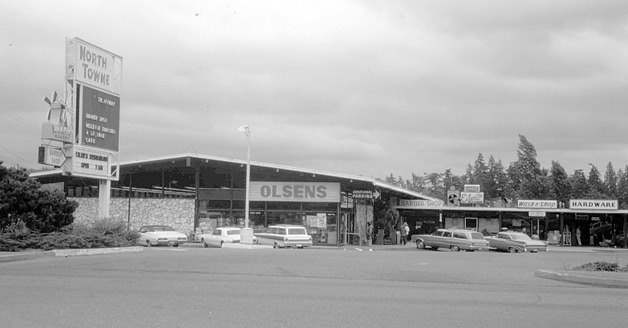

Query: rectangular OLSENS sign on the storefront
[249,181,340,203]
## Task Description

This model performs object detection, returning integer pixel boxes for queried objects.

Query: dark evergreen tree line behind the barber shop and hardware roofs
[384,135,628,209]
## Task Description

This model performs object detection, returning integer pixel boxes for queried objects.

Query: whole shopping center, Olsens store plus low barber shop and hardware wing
[31,154,628,247]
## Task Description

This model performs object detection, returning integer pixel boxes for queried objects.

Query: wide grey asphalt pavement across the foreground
[0,247,628,328]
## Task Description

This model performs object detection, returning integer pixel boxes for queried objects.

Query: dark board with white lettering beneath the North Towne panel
[80,85,120,152]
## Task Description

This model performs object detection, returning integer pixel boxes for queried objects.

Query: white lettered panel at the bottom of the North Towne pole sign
[63,145,118,180]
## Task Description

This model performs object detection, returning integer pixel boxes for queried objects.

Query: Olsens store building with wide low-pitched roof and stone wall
[31,154,437,245]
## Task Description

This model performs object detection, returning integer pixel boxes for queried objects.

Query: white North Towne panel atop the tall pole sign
[65,38,122,95]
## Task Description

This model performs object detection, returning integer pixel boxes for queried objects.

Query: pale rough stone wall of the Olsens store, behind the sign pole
[68,197,195,235]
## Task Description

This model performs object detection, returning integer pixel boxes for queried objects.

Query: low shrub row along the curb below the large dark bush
[0,220,139,252]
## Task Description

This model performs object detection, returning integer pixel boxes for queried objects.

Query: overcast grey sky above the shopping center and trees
[0,0,628,178]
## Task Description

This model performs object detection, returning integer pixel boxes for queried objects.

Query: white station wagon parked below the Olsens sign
[255,224,312,248]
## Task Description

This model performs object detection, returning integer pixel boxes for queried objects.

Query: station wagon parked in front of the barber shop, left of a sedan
[412,229,489,252]
